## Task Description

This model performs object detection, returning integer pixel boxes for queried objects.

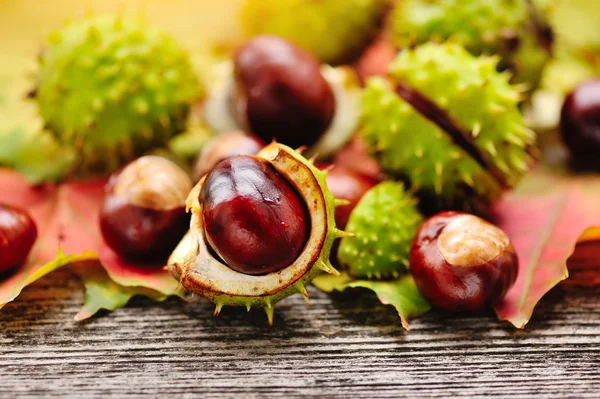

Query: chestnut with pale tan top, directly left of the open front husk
[100,156,192,263]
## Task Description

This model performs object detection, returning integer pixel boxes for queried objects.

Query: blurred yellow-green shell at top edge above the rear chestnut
[241,0,390,64]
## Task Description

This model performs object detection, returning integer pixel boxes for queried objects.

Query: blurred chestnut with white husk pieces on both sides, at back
[204,35,360,157]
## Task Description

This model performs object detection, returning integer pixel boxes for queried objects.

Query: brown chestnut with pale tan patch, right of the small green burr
[409,212,518,312]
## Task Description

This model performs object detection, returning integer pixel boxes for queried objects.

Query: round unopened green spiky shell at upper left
[36,17,201,172]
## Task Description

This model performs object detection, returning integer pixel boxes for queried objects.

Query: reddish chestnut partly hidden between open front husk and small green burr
[320,166,378,230]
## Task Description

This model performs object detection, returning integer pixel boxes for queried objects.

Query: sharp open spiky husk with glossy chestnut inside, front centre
[168,143,345,323]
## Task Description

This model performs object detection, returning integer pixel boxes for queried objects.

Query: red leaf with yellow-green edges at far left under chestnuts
[0,170,182,313]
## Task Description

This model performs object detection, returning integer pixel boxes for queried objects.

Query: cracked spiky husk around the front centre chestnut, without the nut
[167,143,347,323]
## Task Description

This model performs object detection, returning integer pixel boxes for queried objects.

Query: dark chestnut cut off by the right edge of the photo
[560,79,600,169]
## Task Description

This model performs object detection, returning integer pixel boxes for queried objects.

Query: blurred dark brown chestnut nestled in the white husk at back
[234,35,335,148]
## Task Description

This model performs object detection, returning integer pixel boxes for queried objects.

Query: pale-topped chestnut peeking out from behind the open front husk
[194,132,265,182]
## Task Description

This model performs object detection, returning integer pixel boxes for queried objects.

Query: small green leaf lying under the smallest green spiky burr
[313,273,431,331]
